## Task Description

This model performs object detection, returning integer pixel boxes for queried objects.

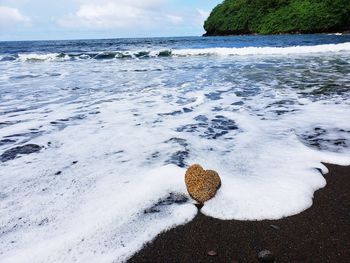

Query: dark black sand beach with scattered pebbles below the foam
[128,164,350,263]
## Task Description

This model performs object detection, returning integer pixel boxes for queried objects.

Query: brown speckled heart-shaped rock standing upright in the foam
[185,164,221,204]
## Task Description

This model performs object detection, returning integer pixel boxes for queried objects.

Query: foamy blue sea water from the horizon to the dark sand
[0,35,350,262]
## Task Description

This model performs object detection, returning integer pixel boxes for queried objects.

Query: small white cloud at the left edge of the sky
[0,6,30,27]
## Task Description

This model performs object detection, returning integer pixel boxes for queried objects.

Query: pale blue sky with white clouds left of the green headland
[0,0,222,41]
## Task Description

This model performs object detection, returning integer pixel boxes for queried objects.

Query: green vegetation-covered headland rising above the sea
[204,0,350,35]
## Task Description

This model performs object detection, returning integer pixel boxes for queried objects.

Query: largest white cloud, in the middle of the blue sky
[57,0,183,29]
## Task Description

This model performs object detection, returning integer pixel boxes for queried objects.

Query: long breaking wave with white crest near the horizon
[0,42,350,62]
